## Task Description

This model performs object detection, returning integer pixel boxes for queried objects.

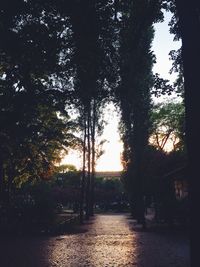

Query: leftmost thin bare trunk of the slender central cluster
[80,116,87,223]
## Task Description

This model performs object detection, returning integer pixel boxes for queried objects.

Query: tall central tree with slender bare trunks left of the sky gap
[70,1,117,222]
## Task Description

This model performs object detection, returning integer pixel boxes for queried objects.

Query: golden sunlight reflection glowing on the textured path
[49,215,136,267]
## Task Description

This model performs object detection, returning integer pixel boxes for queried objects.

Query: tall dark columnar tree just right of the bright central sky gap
[116,1,162,227]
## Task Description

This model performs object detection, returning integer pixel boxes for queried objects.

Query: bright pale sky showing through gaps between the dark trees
[61,12,181,171]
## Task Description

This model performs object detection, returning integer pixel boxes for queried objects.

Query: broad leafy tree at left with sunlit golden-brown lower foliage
[0,1,76,205]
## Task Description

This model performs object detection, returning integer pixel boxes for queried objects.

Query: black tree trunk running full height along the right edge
[175,0,200,267]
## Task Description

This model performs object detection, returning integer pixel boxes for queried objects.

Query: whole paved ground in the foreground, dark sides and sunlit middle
[0,214,190,267]
